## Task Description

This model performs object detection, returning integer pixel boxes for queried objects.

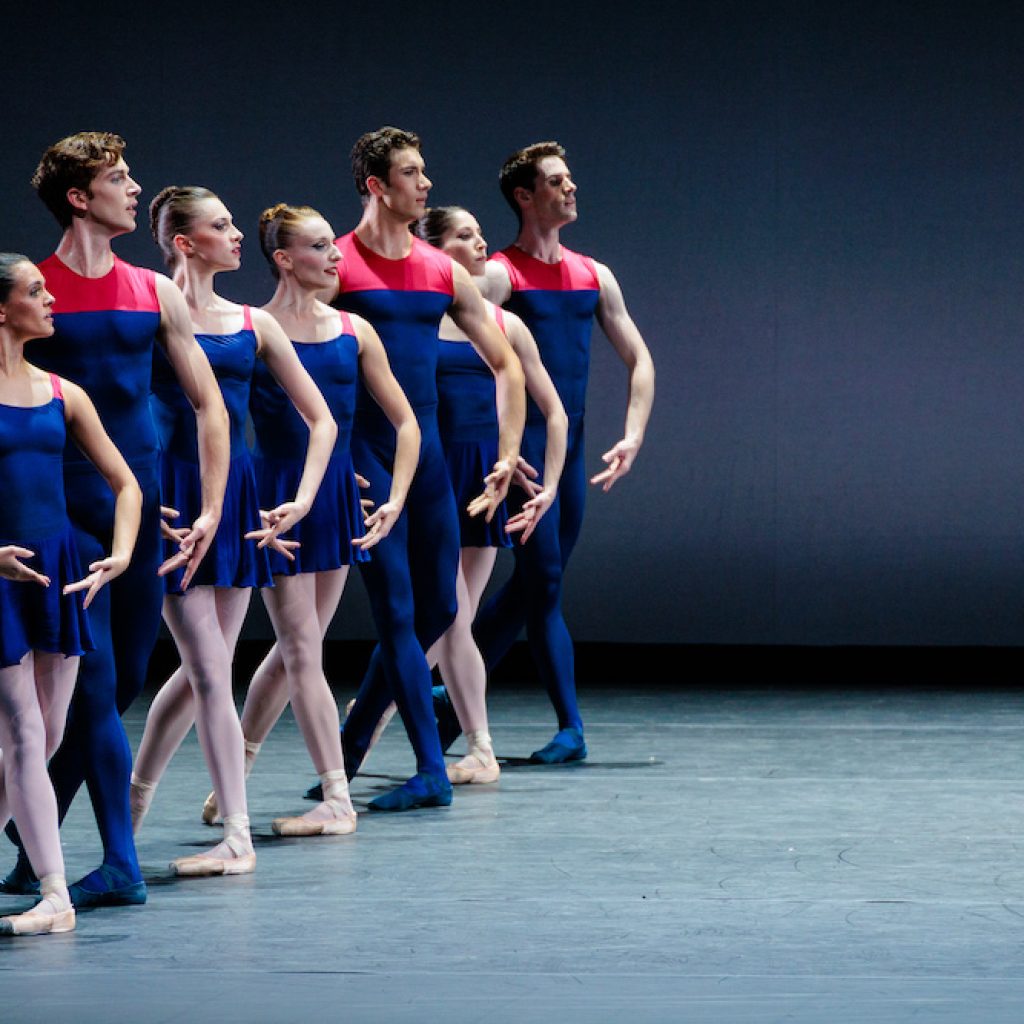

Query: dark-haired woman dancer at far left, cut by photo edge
[0,253,142,935]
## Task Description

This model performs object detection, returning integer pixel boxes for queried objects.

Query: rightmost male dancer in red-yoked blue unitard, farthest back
[466,142,654,764]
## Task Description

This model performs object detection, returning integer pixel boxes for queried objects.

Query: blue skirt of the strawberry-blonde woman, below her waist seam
[256,451,370,575]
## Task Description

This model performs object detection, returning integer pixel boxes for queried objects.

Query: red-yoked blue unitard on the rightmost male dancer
[473,246,600,730]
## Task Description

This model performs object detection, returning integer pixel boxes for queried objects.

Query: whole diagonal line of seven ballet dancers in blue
[0,127,654,935]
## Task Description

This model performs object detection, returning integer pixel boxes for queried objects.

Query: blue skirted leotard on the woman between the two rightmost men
[437,306,512,548]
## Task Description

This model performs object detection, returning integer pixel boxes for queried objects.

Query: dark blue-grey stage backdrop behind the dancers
[0,0,1024,644]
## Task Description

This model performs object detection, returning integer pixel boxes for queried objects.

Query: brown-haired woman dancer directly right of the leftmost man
[131,185,337,876]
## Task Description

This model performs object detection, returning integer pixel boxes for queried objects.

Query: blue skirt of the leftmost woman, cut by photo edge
[0,523,95,669]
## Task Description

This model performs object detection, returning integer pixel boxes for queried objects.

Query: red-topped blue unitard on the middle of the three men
[337,232,459,774]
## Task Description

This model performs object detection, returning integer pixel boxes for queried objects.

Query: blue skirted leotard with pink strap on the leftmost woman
[0,374,93,669]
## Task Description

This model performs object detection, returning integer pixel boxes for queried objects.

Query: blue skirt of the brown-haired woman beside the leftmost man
[160,452,273,594]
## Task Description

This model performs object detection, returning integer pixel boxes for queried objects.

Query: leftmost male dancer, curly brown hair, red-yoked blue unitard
[2,132,228,908]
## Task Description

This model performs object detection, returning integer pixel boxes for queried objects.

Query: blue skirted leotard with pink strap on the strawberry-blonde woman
[249,312,370,575]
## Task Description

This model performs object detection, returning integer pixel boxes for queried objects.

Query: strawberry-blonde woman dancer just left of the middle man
[203,203,420,836]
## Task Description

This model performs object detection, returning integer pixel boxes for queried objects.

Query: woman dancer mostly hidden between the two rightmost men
[417,206,568,784]
